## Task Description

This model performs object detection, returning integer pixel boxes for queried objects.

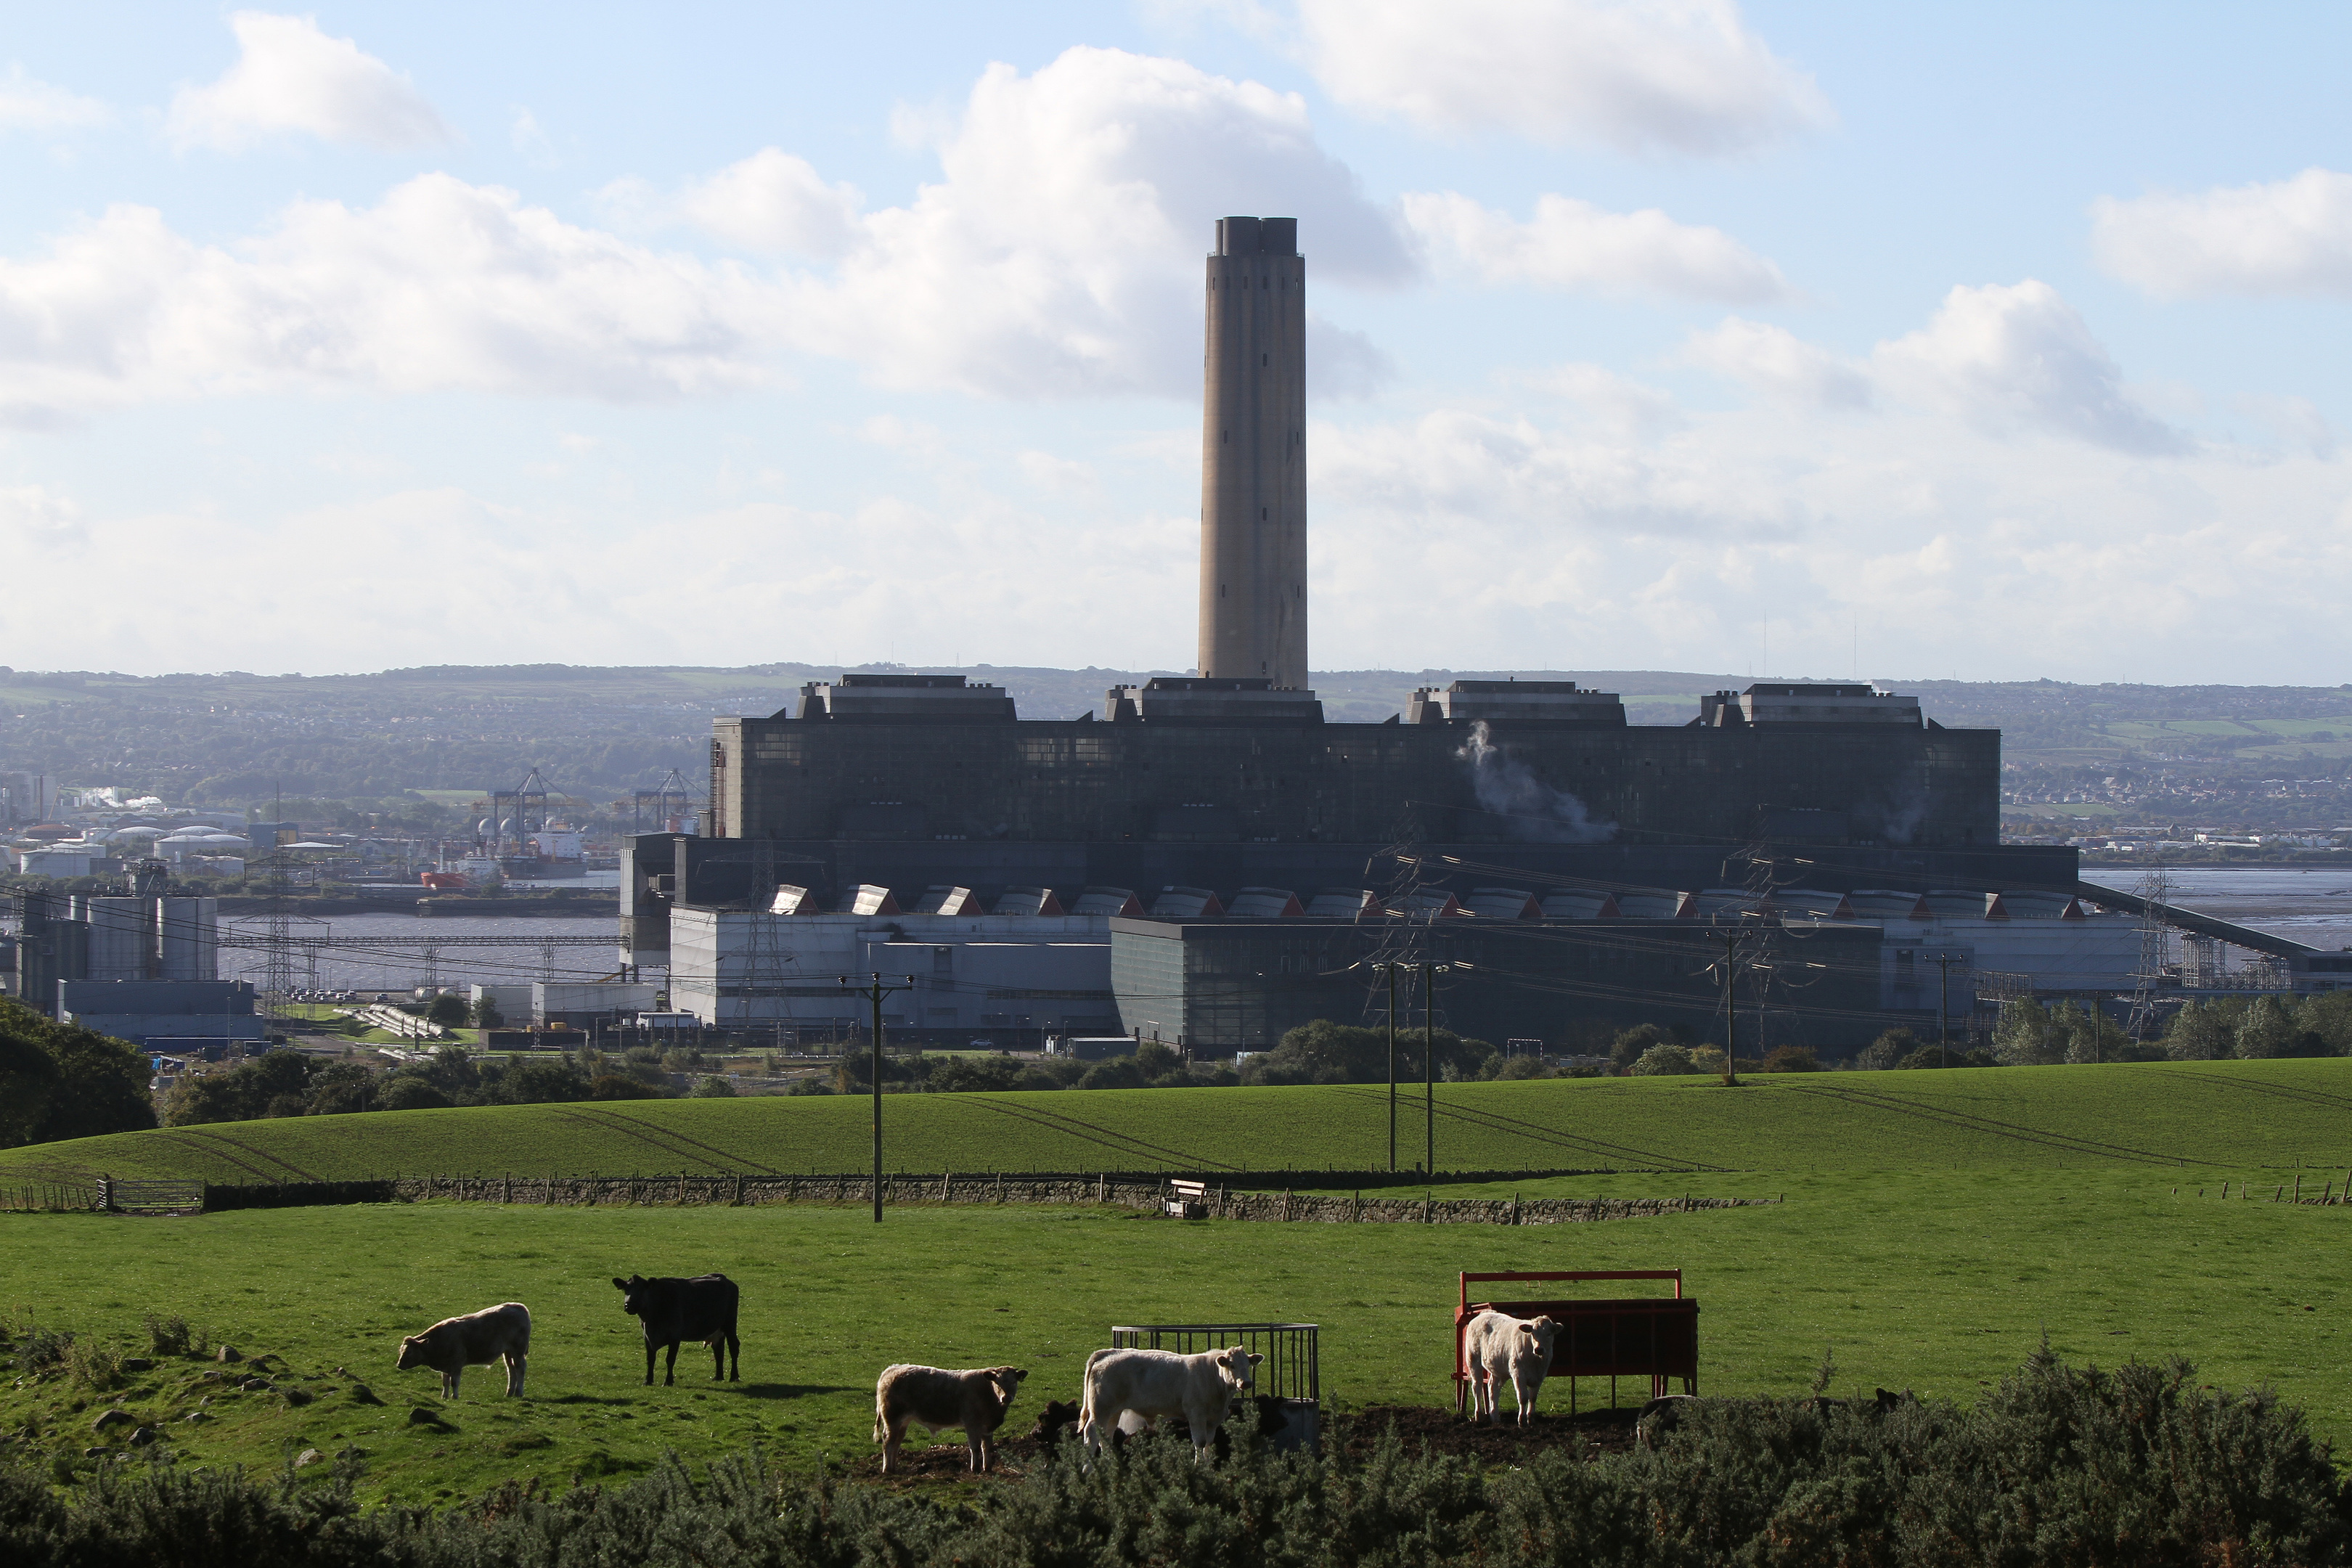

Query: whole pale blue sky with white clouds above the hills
[0,0,2352,687]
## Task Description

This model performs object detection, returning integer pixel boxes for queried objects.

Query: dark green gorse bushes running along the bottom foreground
[0,1352,2348,1568]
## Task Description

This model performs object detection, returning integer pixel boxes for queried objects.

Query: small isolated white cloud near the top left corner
[165,12,454,150]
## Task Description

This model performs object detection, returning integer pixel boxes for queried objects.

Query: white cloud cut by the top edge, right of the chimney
[1298,0,1830,155]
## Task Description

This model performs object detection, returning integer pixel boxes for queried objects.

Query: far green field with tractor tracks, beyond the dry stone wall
[0,1058,2352,1183]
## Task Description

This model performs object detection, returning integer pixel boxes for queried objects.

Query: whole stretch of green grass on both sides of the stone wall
[14,1061,2352,1502]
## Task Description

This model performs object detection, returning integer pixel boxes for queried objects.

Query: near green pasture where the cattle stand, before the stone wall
[0,1168,2352,1502]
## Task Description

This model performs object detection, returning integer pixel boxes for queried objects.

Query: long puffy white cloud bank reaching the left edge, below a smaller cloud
[0,174,783,423]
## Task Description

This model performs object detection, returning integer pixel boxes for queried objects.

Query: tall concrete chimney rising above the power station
[1199,219,1307,687]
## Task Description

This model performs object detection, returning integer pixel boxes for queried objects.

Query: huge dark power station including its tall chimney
[644,219,2136,1051]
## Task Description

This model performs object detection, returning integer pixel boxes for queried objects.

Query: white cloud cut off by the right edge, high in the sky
[2091,169,2352,298]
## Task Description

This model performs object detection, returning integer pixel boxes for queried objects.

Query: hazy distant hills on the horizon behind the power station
[0,663,2352,820]
